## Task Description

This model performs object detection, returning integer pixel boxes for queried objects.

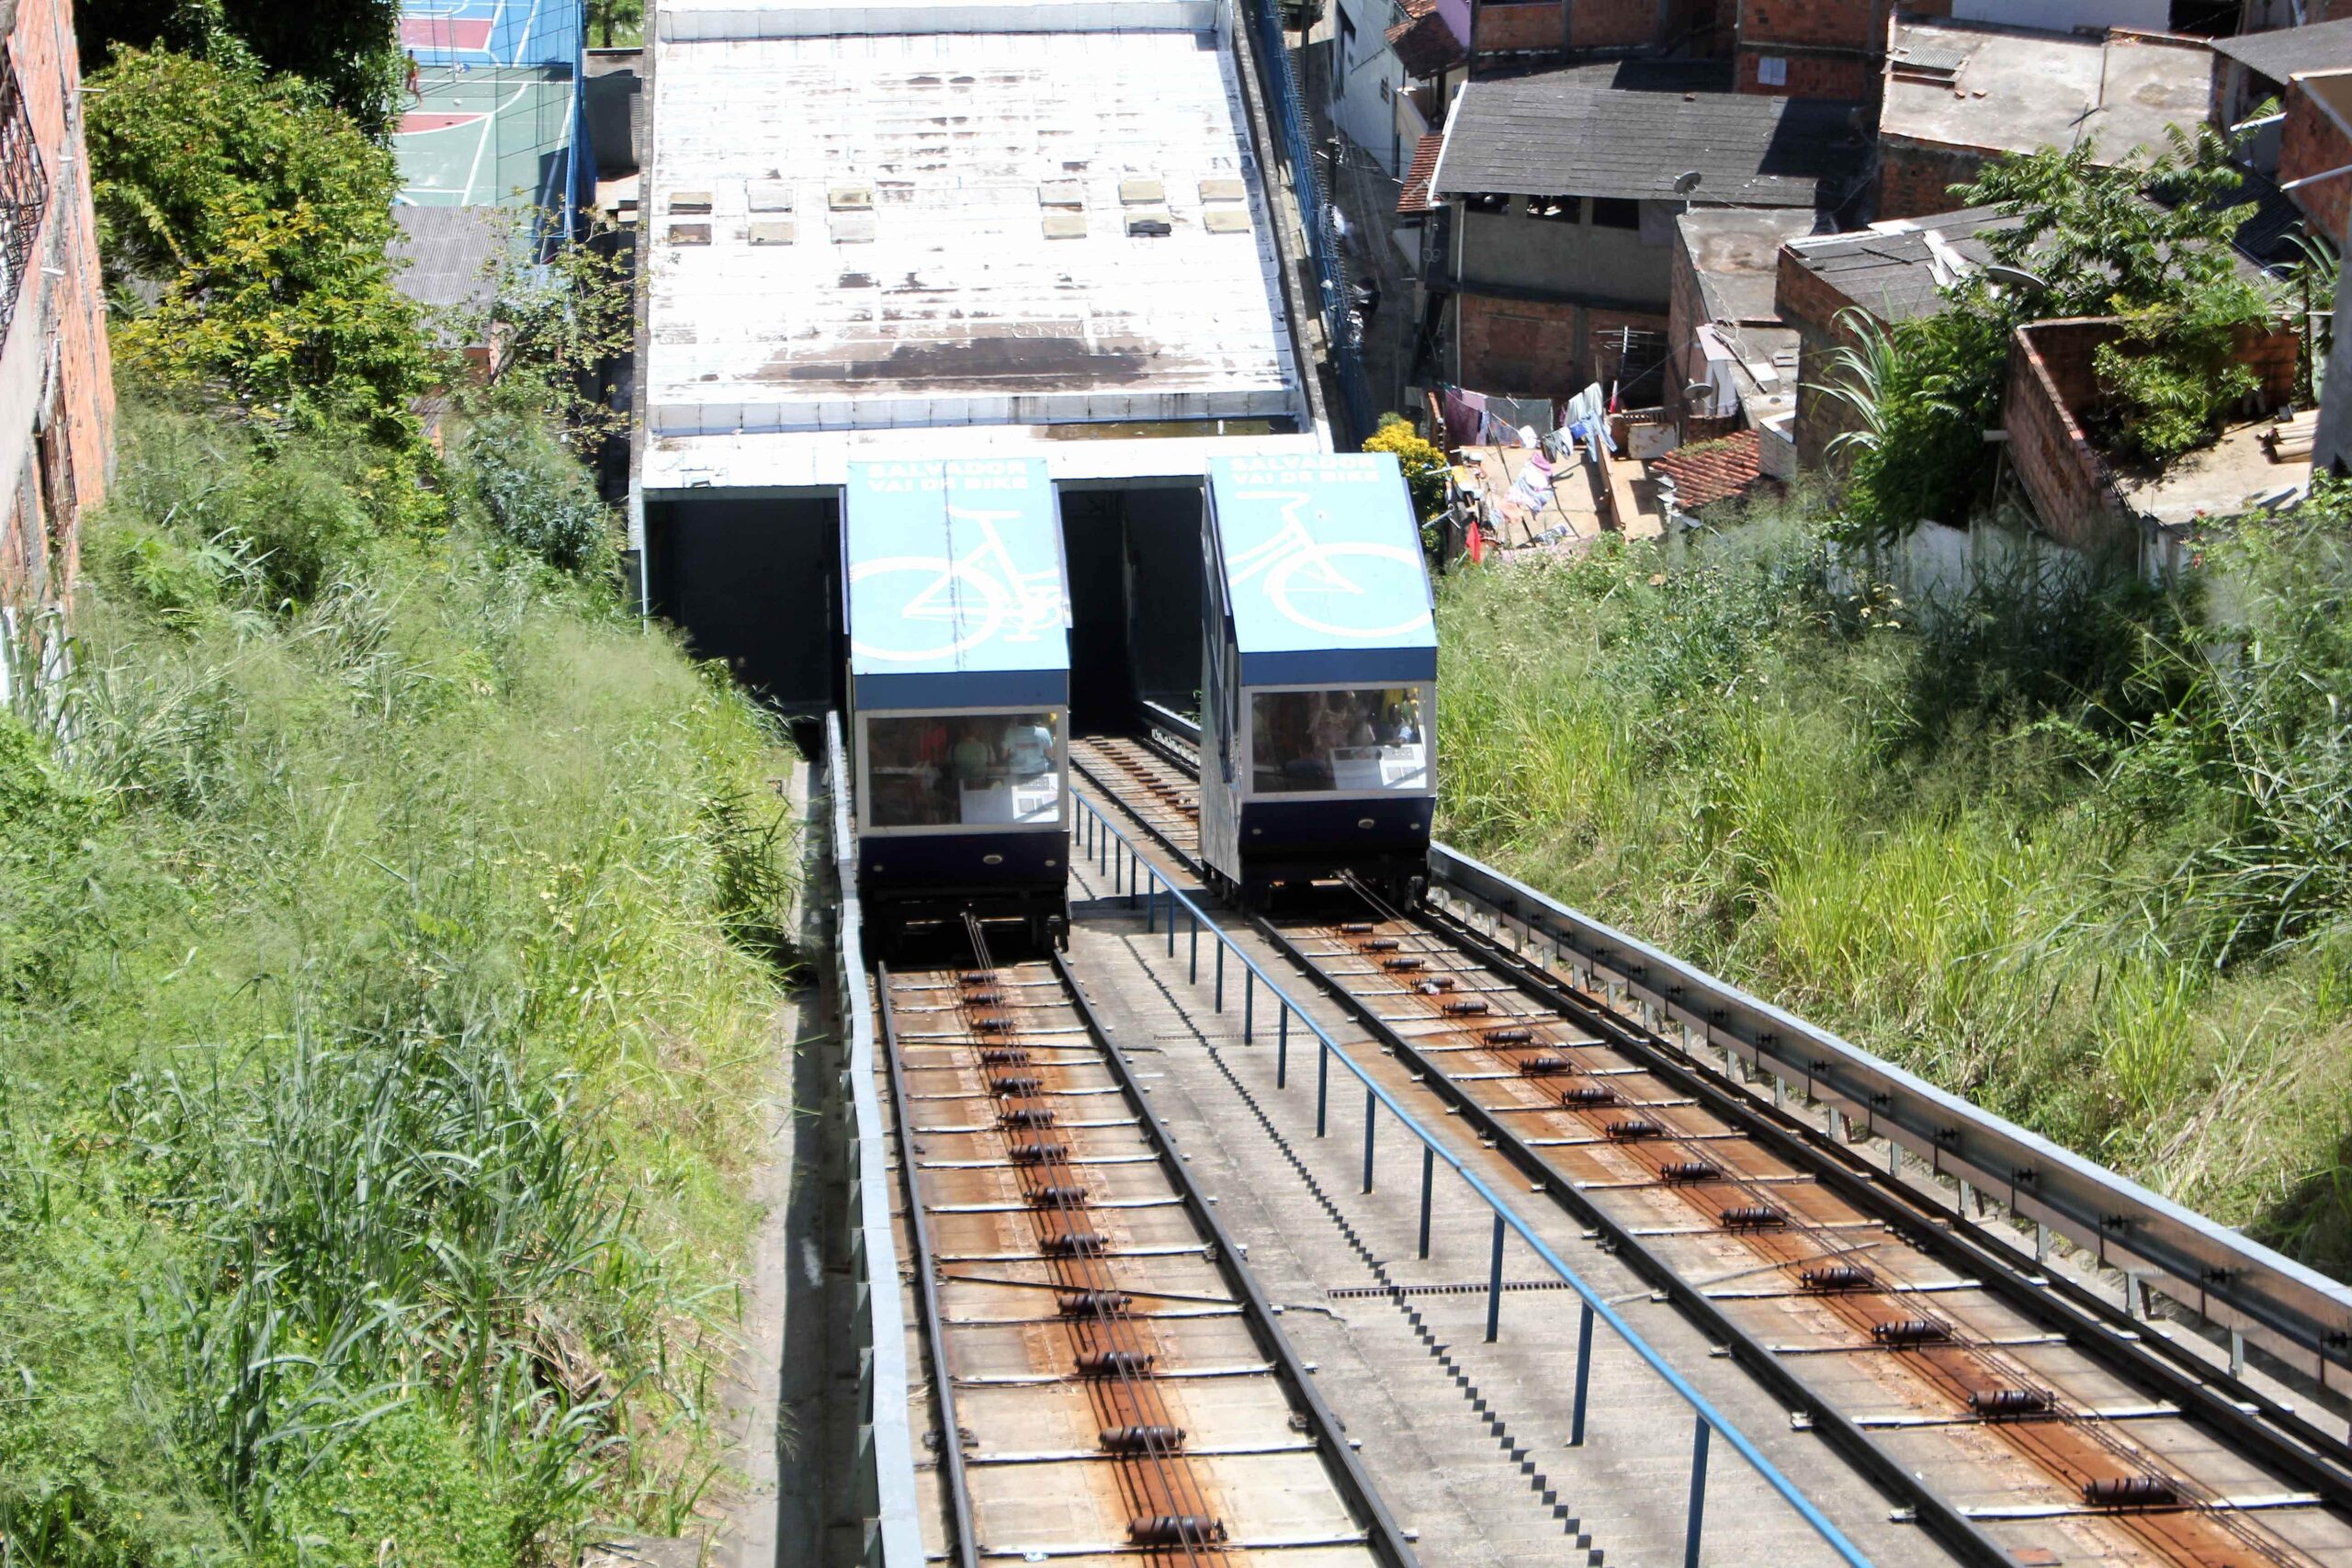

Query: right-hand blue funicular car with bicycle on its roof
[1200,454,1437,905]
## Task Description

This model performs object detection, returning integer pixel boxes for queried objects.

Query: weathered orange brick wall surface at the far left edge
[0,0,115,625]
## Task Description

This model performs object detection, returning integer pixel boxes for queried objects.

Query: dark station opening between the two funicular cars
[1061,482,1202,733]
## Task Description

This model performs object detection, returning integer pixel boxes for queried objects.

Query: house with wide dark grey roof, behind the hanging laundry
[1425,62,1868,402]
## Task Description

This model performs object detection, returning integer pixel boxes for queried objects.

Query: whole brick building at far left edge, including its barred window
[0,0,115,696]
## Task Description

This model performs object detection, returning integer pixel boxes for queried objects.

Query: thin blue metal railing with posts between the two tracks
[1072,799,1870,1568]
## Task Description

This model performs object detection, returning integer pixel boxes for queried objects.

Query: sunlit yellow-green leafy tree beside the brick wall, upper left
[89,50,430,445]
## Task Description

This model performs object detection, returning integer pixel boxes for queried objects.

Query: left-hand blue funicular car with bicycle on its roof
[842,458,1070,952]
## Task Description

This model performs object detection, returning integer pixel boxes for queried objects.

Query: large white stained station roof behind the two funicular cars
[642,28,1306,446]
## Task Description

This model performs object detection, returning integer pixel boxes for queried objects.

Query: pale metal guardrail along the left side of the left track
[826,715,924,1568]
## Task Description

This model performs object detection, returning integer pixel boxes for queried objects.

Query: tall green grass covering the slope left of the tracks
[0,409,793,1568]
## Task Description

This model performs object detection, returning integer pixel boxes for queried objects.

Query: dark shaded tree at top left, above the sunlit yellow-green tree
[73,0,407,136]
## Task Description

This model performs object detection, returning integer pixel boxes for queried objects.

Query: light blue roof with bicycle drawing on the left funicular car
[842,458,1070,707]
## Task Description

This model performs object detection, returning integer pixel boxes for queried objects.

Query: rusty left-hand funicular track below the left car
[875,933,1414,1568]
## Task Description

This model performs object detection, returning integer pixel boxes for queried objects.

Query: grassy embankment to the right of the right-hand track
[1440,517,2352,1274]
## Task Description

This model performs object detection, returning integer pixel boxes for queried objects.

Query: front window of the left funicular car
[865,710,1061,828]
